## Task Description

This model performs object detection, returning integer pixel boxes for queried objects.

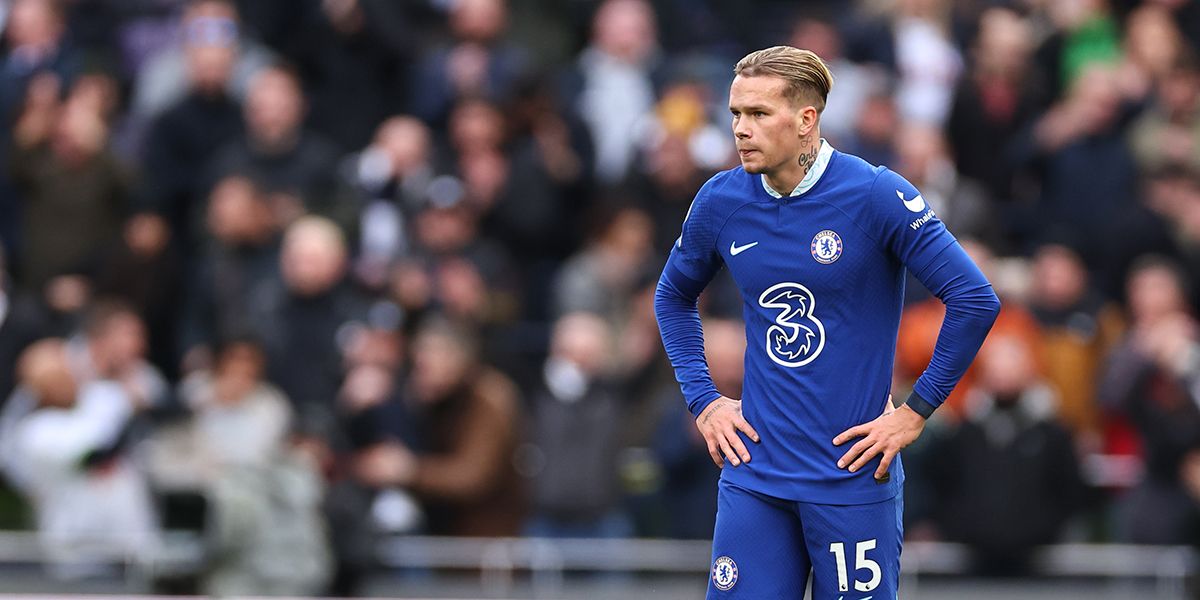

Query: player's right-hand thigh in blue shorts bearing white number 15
[799,496,904,600]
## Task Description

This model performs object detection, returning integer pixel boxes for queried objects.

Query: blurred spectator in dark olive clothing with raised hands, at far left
[11,74,128,289]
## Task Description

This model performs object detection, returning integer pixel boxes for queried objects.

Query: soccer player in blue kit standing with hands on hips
[654,46,1000,600]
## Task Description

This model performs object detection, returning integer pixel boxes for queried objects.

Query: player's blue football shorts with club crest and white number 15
[708,479,904,600]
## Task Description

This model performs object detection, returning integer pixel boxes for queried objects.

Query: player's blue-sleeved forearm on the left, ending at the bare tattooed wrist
[654,264,720,416]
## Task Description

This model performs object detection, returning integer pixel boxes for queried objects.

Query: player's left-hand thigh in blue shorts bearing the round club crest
[708,480,810,600]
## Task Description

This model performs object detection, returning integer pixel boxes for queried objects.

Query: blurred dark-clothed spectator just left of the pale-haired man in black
[180,175,280,372]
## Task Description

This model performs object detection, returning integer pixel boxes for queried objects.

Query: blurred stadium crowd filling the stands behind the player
[0,0,1200,594]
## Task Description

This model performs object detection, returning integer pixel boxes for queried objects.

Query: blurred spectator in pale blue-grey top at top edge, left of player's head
[572,0,661,184]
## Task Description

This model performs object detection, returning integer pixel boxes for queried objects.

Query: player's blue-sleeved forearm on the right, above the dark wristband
[907,244,1000,418]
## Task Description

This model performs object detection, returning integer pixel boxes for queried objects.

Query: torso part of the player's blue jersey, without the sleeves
[700,159,904,502]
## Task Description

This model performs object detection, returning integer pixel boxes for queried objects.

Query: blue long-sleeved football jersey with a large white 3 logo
[656,142,998,504]
